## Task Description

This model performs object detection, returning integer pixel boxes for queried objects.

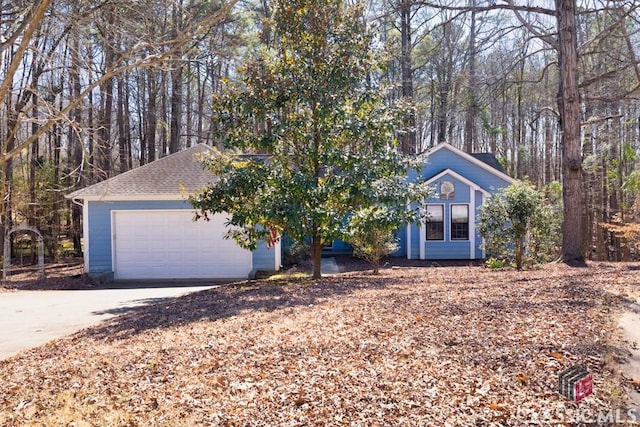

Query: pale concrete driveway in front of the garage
[0,284,216,360]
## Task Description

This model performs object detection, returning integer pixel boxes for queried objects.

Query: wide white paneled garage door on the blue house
[112,210,252,279]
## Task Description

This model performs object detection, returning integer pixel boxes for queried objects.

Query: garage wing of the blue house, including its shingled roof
[66,144,281,280]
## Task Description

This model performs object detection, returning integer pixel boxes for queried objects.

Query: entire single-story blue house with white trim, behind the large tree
[67,143,515,280]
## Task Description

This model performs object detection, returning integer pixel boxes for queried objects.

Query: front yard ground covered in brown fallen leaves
[0,264,640,426]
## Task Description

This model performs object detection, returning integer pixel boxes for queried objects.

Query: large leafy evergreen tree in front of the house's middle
[191,0,426,278]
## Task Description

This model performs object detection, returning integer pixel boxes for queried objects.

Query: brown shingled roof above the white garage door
[66,144,215,199]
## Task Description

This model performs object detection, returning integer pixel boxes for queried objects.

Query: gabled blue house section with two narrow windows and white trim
[396,143,516,260]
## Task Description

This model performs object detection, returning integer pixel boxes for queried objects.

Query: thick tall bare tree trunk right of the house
[556,0,584,263]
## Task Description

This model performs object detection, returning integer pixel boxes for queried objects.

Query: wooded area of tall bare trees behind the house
[0,0,640,260]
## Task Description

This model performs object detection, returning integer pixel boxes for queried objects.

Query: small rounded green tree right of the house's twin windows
[478,181,561,269]
